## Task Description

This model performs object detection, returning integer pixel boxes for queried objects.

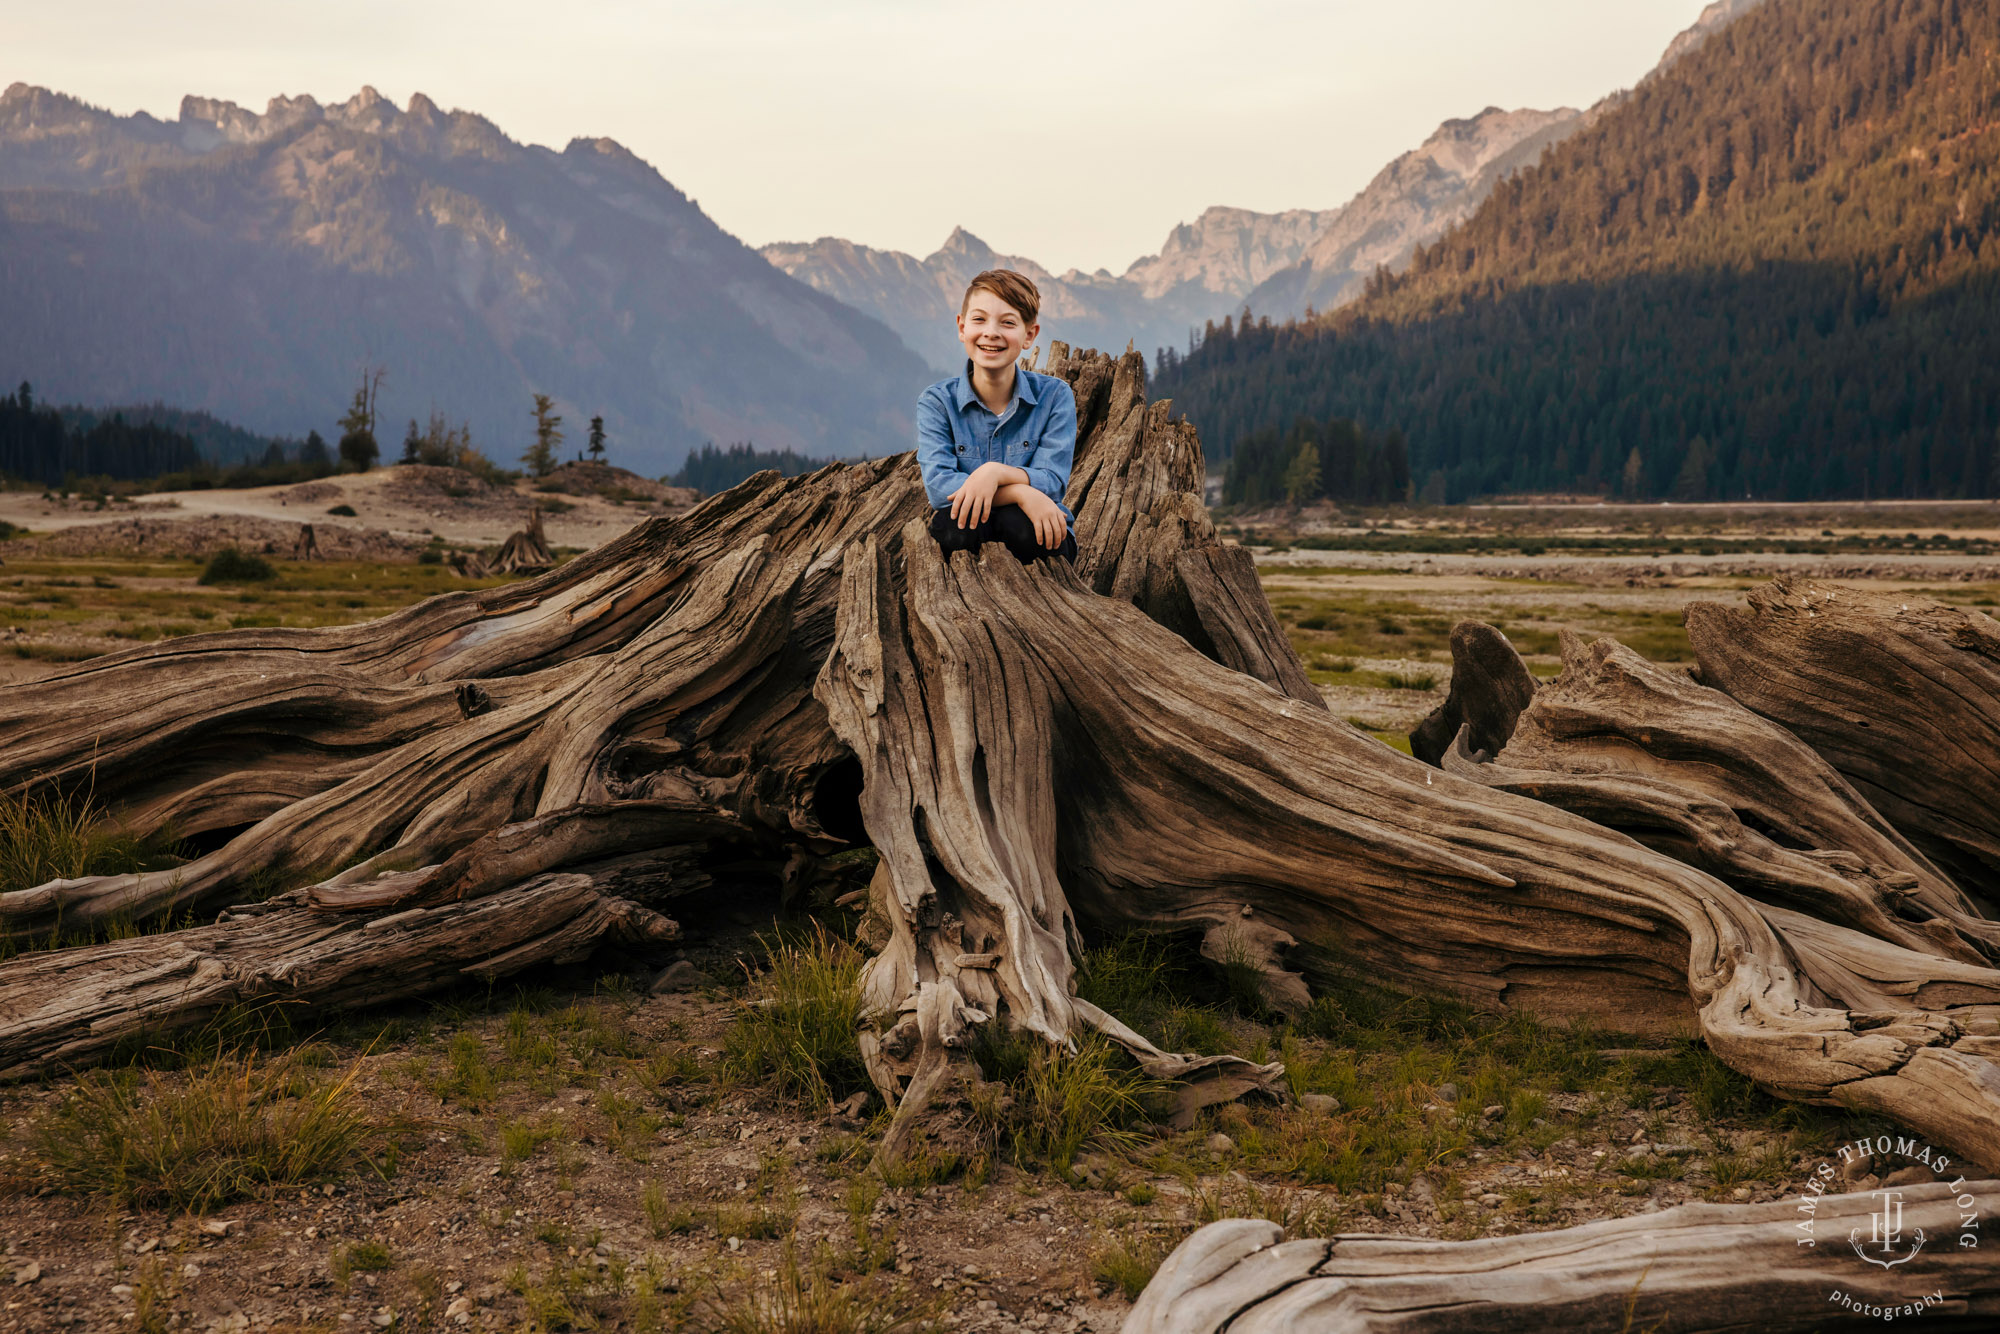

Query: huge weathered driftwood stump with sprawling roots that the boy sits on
[0,348,2000,1162]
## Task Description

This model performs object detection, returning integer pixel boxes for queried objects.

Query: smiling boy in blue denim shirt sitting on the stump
[916,268,1076,564]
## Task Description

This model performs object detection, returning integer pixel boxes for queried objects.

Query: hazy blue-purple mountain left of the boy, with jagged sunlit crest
[0,84,928,474]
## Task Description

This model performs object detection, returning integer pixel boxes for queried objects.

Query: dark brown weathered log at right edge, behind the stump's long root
[1686,580,2000,916]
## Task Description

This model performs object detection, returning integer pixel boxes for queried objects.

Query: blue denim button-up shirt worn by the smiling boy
[916,360,1076,528]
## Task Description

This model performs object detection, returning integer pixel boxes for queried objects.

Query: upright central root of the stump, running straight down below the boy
[818,520,1284,1158]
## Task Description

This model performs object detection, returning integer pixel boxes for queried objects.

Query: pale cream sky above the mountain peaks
[0,0,1704,272]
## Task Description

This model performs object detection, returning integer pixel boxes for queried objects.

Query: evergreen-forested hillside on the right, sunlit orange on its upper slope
[1160,0,2000,500]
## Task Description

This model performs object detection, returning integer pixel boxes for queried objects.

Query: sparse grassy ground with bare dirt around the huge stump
[0,506,2000,1334]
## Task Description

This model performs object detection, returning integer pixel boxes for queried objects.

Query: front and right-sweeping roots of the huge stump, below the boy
[820,526,2000,1162]
